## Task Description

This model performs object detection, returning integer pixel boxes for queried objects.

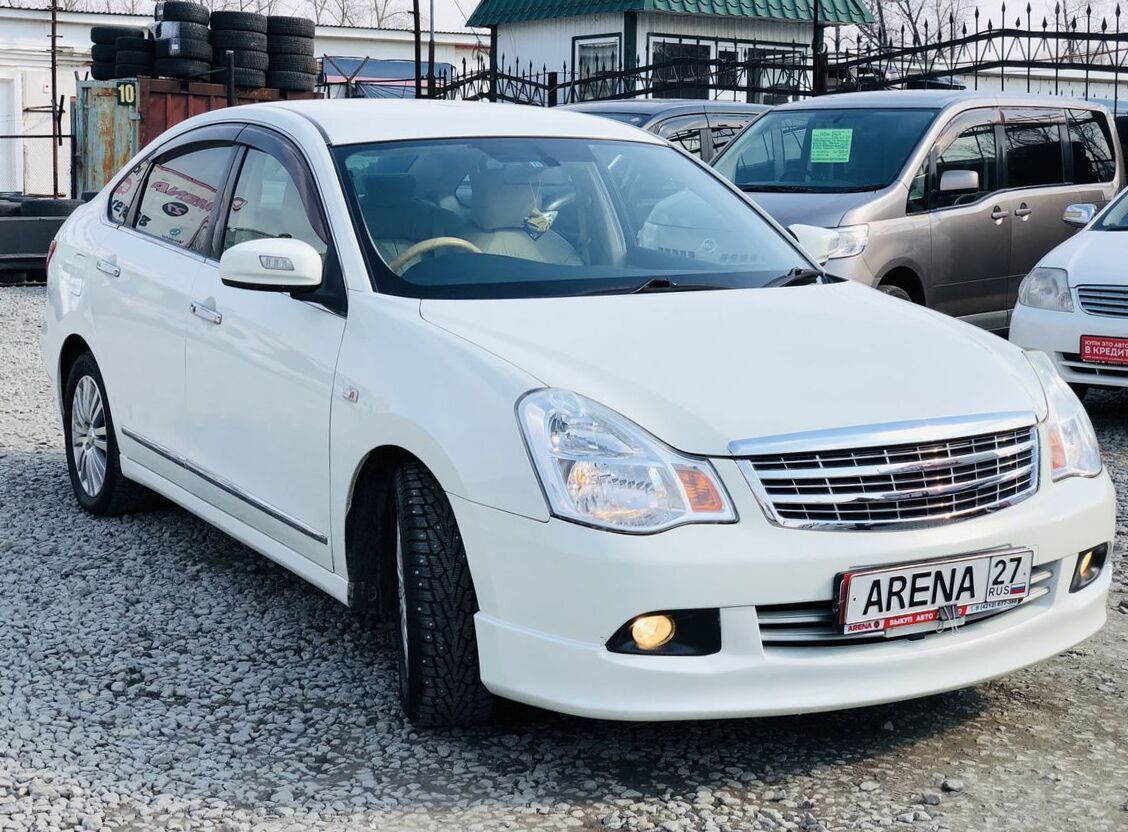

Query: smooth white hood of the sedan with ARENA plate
[421,282,1045,455]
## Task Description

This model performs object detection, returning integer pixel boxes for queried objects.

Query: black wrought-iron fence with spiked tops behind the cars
[431,3,1128,107]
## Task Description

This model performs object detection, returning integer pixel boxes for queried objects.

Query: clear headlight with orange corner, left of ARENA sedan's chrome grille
[517,389,737,533]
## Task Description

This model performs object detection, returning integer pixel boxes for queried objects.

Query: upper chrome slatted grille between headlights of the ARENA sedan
[733,414,1038,529]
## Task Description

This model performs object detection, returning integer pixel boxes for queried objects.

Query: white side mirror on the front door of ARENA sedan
[219,237,321,292]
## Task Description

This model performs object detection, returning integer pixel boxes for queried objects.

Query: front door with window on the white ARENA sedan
[185,129,345,569]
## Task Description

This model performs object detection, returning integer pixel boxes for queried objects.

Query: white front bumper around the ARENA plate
[451,460,1114,719]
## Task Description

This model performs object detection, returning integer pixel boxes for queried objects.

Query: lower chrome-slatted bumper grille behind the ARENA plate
[756,565,1054,647]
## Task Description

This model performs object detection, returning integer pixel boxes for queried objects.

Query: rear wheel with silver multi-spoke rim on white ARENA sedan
[63,353,157,515]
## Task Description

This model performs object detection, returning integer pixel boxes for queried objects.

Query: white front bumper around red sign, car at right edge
[1010,306,1128,387]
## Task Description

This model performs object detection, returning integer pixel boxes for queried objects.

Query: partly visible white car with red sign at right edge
[1011,191,1128,398]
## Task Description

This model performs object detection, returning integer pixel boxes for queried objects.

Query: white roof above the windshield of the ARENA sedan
[217,98,661,144]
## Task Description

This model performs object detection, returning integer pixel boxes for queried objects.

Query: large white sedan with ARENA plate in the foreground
[43,100,1114,724]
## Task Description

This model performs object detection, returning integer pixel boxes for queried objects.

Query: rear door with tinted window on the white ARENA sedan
[91,129,237,485]
